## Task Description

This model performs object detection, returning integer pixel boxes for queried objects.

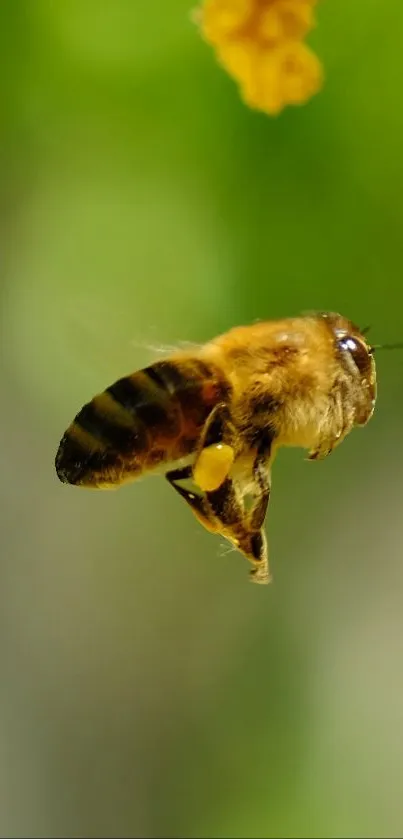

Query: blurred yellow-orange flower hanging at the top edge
[197,0,323,115]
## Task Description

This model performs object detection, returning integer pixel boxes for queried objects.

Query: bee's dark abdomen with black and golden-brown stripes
[56,358,228,488]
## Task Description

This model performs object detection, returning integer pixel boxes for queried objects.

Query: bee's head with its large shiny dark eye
[321,312,376,425]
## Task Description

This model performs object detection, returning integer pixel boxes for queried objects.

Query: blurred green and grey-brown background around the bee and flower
[0,0,403,837]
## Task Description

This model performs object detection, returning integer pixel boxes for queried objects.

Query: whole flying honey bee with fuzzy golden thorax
[56,312,402,583]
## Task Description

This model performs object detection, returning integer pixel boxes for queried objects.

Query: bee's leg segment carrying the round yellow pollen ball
[193,403,235,492]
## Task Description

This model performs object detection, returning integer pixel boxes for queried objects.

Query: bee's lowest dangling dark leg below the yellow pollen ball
[206,478,270,584]
